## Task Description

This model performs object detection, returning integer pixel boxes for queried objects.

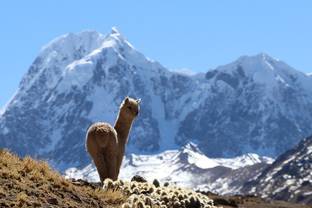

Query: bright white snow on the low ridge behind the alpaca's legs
[65,143,272,190]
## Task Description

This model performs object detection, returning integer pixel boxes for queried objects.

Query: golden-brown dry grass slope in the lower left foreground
[0,150,127,208]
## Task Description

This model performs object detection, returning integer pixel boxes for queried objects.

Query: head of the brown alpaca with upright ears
[120,97,141,120]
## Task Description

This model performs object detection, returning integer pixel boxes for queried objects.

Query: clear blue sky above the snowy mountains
[0,0,312,108]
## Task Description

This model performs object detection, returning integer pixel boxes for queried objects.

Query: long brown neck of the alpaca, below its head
[114,115,132,150]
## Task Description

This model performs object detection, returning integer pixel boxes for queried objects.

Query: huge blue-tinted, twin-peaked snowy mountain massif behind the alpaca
[0,29,312,170]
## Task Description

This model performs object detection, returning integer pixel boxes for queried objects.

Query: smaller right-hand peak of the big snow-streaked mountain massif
[182,54,312,156]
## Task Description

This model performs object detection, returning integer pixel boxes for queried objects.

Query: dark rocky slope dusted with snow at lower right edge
[243,137,312,204]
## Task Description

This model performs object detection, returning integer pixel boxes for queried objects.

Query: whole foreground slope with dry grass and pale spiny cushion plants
[0,150,308,208]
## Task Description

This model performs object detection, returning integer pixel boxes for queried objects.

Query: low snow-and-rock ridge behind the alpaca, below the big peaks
[65,143,273,194]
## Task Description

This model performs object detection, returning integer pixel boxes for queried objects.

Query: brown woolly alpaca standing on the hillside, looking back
[86,97,141,183]
